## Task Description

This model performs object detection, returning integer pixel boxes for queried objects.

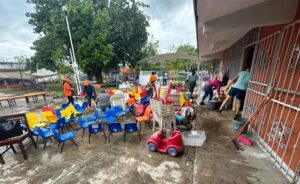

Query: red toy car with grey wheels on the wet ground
[147,130,183,157]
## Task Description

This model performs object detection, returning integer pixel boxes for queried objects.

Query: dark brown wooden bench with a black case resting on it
[0,114,37,165]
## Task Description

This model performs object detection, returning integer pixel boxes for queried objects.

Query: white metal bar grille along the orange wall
[243,20,300,182]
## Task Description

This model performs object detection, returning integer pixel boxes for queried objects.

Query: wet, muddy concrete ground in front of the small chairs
[0,100,288,184]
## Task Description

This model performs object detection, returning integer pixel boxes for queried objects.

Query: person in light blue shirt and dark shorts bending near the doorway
[219,68,250,117]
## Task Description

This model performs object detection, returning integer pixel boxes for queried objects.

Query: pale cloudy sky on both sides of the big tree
[0,0,196,59]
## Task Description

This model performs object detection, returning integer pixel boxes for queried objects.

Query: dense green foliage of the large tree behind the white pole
[27,0,149,82]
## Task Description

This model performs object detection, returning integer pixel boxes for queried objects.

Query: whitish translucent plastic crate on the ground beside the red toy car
[182,131,206,146]
